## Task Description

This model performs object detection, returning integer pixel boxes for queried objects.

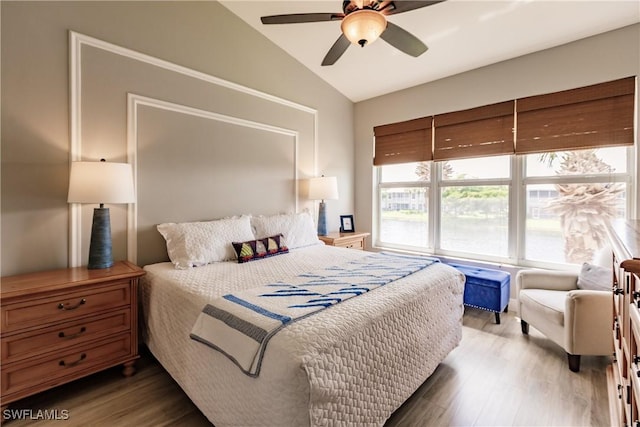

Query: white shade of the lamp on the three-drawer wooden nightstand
[67,162,136,203]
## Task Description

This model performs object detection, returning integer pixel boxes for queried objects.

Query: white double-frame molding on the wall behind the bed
[69,31,318,267]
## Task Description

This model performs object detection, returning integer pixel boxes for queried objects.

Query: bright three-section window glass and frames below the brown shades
[376,147,632,267]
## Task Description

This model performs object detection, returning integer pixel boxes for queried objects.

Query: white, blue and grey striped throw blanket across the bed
[190,253,439,377]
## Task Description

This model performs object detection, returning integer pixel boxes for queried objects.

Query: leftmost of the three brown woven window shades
[373,117,433,166]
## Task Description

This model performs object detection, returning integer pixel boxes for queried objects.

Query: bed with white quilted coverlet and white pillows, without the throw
[140,214,464,426]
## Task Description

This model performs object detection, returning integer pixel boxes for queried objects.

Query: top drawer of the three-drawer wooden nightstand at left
[2,280,131,335]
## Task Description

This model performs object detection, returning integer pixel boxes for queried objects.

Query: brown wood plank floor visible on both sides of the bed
[2,308,610,427]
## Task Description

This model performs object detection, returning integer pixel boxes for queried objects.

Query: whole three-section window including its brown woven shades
[374,76,637,267]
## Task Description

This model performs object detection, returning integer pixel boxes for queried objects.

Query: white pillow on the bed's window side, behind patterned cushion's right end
[251,212,322,249]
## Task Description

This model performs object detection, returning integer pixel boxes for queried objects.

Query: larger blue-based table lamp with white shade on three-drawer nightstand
[67,159,136,269]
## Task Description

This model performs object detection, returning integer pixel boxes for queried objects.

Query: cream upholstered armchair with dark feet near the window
[516,264,613,372]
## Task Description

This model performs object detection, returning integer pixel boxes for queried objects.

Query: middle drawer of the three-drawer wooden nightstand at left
[2,308,131,364]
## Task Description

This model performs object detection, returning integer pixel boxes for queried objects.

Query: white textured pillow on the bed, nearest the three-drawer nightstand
[157,215,255,269]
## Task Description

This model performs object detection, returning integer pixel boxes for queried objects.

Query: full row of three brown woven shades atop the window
[373,77,636,166]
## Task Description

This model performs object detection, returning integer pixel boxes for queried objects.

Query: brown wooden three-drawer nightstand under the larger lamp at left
[0,261,145,417]
